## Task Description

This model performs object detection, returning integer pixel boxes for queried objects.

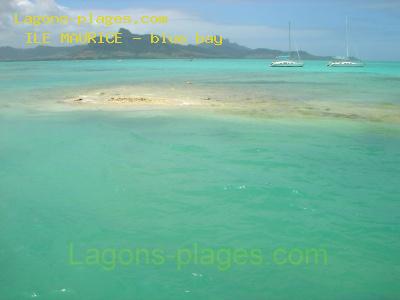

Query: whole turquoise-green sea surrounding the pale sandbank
[0,60,400,300]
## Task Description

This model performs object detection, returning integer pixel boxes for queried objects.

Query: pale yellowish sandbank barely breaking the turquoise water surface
[43,82,400,123]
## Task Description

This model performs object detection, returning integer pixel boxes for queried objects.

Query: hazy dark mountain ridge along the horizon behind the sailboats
[0,28,331,61]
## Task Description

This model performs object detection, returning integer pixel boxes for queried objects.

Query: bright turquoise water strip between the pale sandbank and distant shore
[0,59,400,104]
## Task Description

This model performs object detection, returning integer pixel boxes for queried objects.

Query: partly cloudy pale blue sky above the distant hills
[0,0,400,61]
